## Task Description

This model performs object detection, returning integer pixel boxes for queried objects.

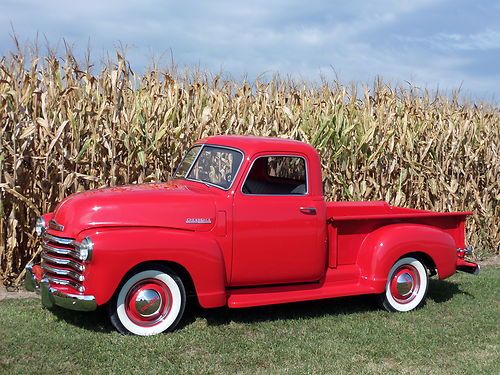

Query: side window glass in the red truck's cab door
[242,156,307,195]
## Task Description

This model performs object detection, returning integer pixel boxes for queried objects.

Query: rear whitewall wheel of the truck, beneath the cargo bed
[381,257,429,312]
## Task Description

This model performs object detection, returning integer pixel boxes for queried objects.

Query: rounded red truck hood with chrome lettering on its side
[49,182,215,238]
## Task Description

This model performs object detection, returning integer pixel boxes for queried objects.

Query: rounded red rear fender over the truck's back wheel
[358,224,456,293]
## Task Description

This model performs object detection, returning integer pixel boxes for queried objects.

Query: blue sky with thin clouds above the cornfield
[0,0,500,103]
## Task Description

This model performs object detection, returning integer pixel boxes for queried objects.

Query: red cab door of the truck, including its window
[231,155,326,286]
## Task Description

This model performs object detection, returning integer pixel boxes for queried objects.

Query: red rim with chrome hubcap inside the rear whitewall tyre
[389,264,420,304]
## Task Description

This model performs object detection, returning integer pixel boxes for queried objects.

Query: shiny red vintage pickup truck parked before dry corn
[25,136,479,335]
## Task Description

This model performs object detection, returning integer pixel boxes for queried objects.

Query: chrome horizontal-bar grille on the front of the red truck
[42,233,85,292]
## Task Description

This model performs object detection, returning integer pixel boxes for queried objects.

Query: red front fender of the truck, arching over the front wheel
[78,228,226,307]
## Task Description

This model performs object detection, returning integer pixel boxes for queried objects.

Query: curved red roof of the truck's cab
[196,135,317,156]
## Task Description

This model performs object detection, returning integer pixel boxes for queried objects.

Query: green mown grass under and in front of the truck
[0,268,500,374]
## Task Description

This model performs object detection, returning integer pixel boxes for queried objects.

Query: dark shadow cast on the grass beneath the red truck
[48,280,470,333]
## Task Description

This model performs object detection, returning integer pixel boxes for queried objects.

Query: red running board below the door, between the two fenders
[227,282,376,309]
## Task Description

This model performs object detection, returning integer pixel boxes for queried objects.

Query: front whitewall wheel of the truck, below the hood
[109,267,186,336]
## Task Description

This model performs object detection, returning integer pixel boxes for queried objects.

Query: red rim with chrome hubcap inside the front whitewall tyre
[125,279,172,327]
